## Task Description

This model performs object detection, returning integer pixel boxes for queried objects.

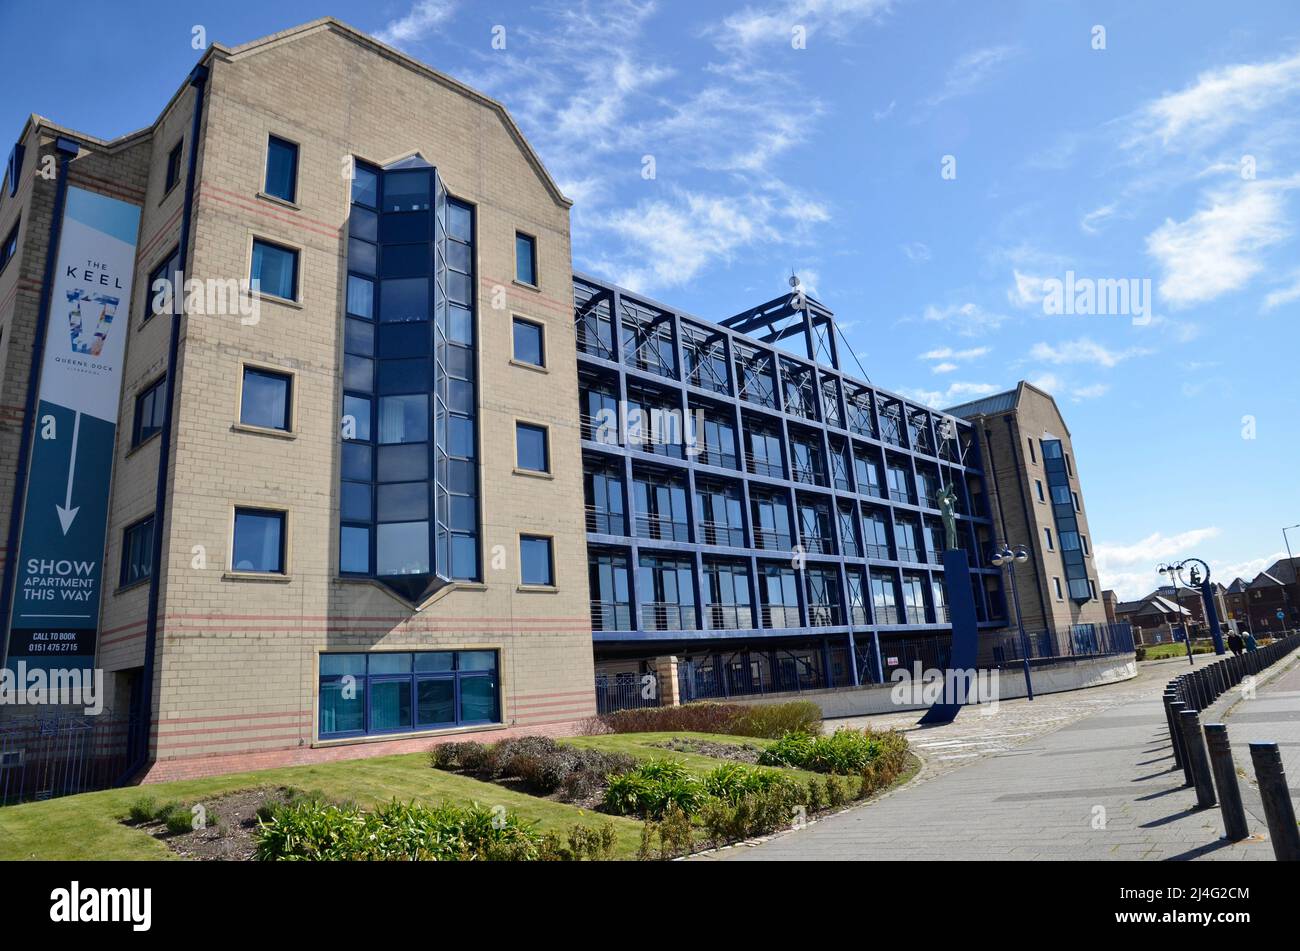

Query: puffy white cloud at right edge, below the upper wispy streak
[1147,182,1295,307]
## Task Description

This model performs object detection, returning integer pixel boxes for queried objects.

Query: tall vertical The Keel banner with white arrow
[7,187,140,669]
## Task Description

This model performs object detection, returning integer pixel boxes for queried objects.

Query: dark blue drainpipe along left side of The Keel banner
[0,136,81,660]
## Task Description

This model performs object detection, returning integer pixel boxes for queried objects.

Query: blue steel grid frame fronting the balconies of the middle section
[573,274,1006,685]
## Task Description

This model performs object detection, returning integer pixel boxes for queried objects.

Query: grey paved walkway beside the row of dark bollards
[699,655,1300,860]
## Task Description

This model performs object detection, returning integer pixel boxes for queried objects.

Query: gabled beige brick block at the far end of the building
[948,381,1106,638]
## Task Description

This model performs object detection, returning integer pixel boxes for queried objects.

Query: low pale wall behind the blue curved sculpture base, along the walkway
[728,653,1138,720]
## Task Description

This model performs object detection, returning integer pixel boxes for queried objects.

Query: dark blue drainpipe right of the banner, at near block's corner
[117,62,208,786]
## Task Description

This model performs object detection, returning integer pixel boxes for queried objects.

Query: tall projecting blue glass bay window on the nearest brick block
[339,156,480,603]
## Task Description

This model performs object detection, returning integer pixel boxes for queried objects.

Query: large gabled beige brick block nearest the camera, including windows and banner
[0,19,594,776]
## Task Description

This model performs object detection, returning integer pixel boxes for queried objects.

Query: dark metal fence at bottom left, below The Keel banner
[0,713,134,805]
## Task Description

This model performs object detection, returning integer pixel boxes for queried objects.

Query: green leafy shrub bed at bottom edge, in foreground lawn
[255,800,542,861]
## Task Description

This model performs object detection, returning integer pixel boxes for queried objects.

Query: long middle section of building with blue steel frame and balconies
[573,275,1005,699]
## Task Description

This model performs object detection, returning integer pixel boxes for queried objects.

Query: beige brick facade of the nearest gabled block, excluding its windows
[0,21,594,778]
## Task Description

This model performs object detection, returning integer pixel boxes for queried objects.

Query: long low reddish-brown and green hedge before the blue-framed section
[601,700,822,739]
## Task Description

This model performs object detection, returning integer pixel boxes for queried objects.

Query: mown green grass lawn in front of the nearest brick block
[0,754,641,861]
